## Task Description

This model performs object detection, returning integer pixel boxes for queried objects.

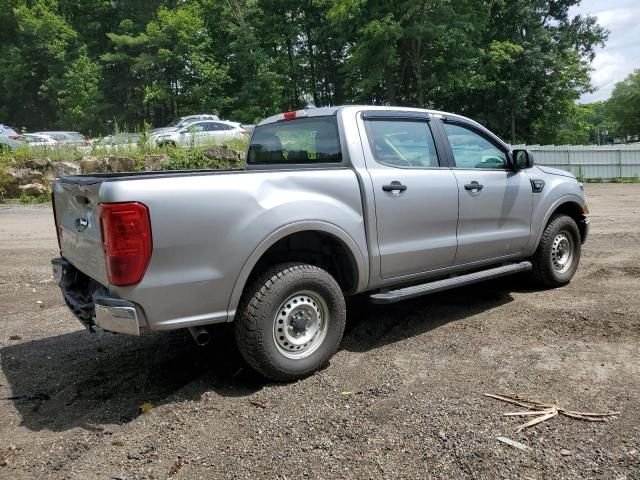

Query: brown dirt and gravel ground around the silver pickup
[0,184,640,480]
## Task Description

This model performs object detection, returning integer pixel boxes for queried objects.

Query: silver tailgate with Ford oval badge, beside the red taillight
[53,180,108,285]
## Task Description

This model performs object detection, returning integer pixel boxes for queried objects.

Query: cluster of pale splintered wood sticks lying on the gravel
[484,393,620,432]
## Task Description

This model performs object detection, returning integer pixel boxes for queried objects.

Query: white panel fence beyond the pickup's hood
[513,144,640,180]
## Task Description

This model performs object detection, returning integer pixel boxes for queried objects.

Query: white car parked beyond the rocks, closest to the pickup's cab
[149,120,248,147]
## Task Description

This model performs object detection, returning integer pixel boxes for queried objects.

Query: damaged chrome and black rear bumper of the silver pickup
[51,258,140,335]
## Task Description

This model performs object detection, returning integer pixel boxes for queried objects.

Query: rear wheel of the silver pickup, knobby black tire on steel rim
[235,263,346,381]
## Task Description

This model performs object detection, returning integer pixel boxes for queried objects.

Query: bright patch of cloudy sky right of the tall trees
[569,0,640,103]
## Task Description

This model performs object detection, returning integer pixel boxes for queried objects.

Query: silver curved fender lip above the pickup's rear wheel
[227,220,369,322]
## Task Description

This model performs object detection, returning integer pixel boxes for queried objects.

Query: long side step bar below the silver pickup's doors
[370,262,532,303]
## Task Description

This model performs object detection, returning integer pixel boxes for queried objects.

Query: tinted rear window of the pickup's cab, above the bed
[247,116,342,165]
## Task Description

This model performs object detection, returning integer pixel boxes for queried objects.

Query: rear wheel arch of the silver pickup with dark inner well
[228,221,369,321]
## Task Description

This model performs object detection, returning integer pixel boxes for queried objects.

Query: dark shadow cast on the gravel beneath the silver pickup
[0,279,528,431]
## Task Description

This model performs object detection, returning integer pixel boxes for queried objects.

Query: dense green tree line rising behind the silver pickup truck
[0,0,606,142]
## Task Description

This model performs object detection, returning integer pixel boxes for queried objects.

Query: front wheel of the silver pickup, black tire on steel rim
[531,214,582,288]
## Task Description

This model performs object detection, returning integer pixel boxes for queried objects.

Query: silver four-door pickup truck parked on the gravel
[52,106,589,380]
